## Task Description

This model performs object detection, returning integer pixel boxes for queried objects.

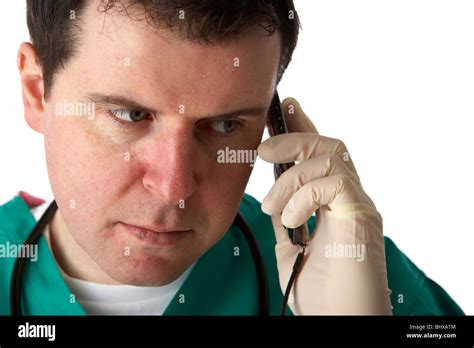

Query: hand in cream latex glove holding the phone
[258,98,393,315]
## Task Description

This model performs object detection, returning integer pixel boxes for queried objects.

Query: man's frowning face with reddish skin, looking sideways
[37,5,280,285]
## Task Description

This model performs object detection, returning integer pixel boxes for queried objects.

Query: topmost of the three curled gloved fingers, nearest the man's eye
[257,133,357,174]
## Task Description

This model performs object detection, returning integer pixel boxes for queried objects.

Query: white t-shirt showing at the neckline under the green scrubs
[31,202,195,315]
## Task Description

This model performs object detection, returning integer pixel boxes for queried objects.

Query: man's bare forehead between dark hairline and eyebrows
[65,4,280,114]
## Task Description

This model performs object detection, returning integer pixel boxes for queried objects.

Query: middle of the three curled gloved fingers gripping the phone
[262,153,360,215]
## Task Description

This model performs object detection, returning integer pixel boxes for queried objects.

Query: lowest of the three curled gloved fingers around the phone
[281,174,372,228]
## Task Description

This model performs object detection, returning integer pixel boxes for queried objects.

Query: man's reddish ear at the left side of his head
[17,42,45,133]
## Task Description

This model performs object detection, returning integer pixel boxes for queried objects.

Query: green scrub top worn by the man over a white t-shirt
[0,194,464,315]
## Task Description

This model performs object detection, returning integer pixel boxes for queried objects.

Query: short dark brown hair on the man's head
[27,0,300,99]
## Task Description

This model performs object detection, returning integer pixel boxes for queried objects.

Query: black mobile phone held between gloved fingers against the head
[267,92,308,245]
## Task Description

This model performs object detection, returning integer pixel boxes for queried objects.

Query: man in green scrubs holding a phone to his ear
[0,0,462,315]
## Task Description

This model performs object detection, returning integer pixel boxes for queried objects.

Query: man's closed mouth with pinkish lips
[120,222,192,247]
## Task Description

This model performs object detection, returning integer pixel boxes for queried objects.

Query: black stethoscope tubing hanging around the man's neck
[10,201,269,316]
